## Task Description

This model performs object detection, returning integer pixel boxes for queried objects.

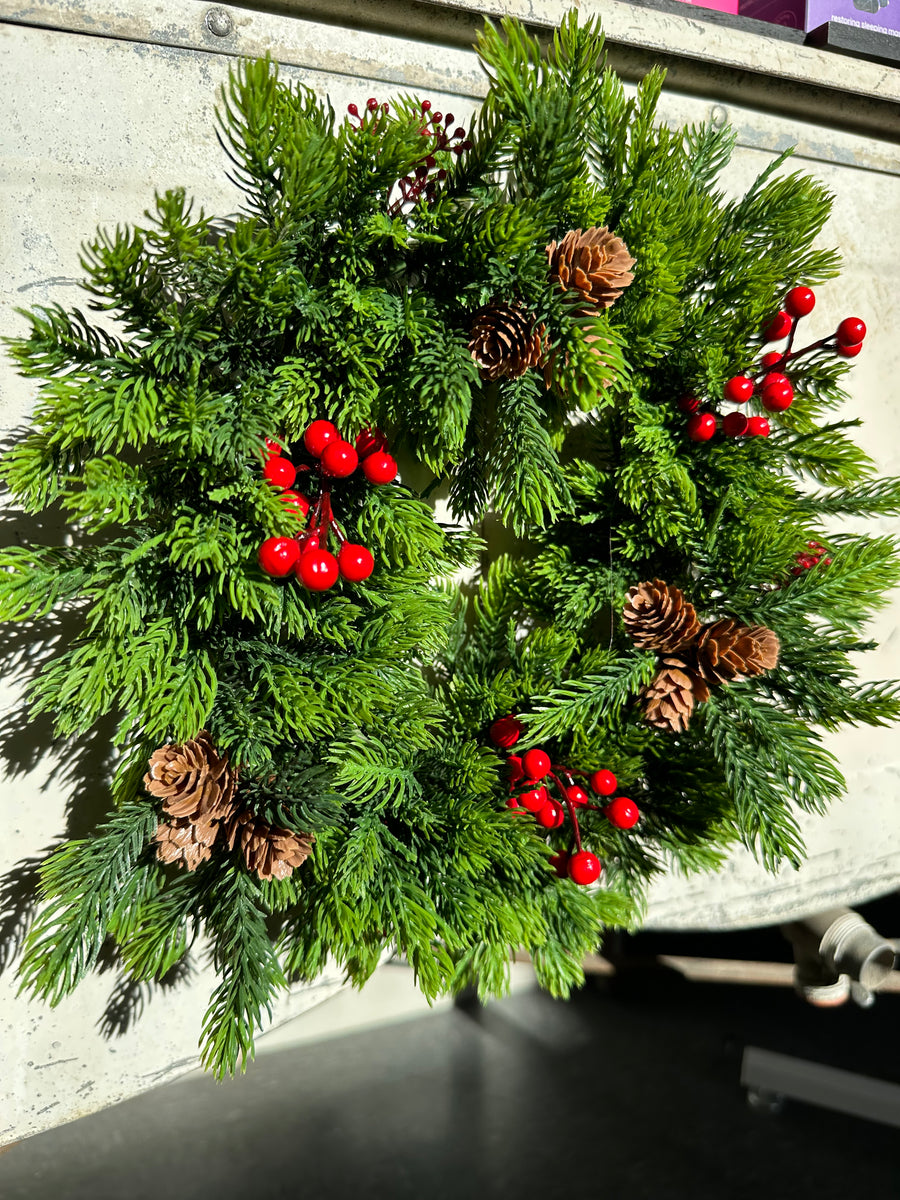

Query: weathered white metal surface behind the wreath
[0,0,900,1145]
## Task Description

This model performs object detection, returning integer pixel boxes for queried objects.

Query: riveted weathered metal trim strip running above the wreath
[0,0,900,142]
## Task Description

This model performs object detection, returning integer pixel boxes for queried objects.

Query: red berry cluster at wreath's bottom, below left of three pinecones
[490,715,641,884]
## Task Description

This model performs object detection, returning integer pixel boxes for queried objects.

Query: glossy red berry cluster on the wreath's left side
[258,421,397,592]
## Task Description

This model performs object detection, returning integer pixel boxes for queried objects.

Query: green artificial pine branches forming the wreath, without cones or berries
[0,16,900,1074]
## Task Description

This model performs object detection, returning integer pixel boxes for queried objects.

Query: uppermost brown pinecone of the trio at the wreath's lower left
[144,730,235,822]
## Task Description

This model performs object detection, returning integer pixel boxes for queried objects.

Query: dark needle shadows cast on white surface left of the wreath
[0,451,193,1038]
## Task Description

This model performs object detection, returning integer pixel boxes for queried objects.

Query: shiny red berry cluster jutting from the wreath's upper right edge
[678,288,865,442]
